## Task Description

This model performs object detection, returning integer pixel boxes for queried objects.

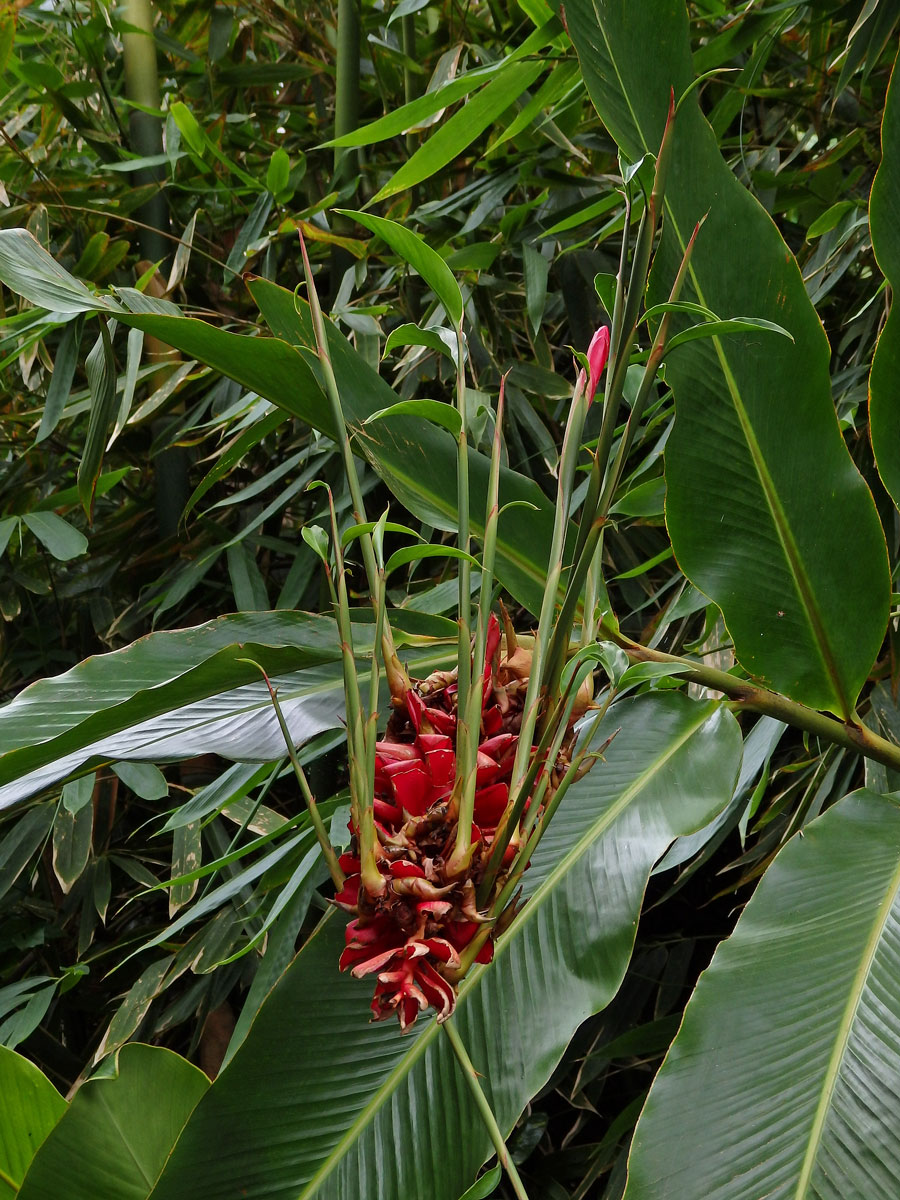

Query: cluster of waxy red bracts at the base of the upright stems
[335,616,530,1031]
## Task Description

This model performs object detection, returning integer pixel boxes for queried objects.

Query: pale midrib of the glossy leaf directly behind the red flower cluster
[298,706,713,1200]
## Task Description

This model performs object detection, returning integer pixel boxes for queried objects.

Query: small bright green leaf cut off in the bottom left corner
[0,1046,66,1200]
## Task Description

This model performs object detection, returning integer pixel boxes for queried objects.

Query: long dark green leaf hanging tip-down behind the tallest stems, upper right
[565,0,889,718]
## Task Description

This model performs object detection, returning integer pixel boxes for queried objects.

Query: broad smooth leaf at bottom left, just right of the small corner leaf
[19,1043,209,1200]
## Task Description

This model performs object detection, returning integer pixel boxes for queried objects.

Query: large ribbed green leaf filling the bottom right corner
[625,791,900,1200]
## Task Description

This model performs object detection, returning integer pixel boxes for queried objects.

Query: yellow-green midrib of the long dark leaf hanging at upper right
[593,0,853,720]
